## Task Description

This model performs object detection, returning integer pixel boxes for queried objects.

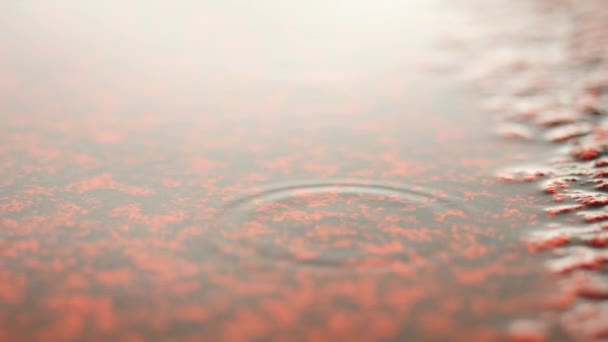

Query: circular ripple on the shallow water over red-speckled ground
[210,179,466,270]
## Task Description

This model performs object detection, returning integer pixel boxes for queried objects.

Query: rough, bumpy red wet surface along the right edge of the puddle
[456,1,608,341]
